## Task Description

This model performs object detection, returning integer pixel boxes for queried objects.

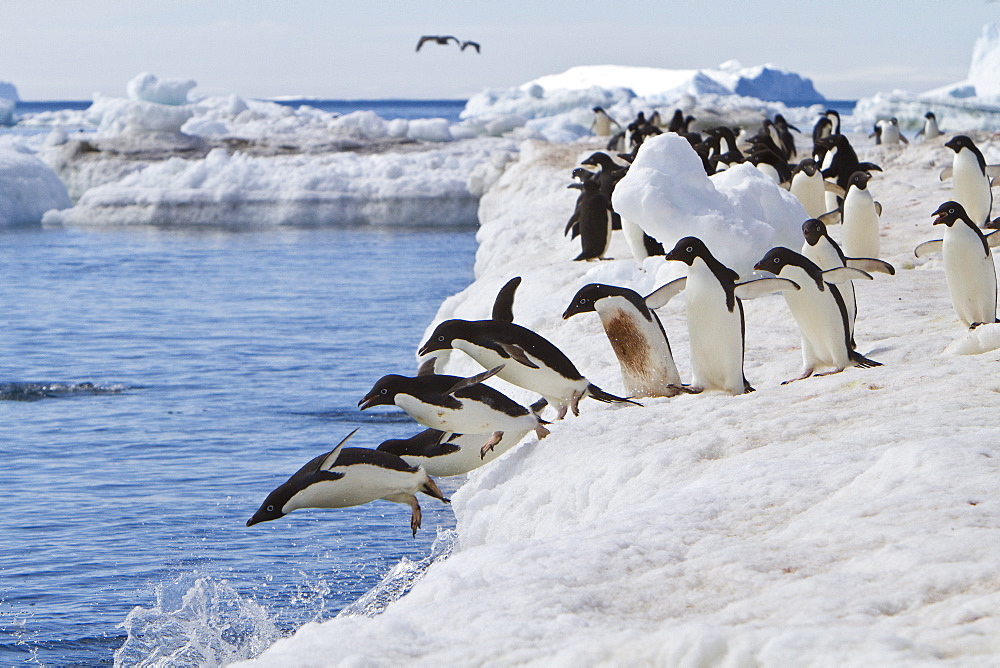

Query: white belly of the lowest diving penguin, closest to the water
[282,464,427,513]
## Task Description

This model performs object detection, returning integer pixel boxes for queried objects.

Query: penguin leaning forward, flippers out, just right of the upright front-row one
[754,246,881,385]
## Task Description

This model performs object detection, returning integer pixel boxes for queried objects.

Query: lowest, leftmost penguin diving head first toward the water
[247,429,449,536]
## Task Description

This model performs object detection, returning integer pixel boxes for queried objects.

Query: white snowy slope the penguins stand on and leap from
[244,129,1000,666]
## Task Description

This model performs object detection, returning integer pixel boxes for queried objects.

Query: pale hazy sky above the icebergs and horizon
[0,0,1000,100]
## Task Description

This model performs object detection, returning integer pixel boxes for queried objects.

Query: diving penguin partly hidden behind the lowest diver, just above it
[378,429,530,478]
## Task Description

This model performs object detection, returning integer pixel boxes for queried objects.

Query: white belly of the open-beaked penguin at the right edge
[941,227,997,327]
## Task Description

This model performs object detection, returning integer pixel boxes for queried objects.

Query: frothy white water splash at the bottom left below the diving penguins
[115,575,282,668]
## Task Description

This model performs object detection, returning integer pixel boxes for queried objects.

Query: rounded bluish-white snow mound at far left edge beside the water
[0,147,71,227]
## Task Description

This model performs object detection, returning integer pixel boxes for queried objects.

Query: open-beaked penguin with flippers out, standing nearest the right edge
[914,201,998,329]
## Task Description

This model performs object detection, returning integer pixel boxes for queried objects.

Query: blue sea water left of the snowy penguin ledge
[0,101,476,666]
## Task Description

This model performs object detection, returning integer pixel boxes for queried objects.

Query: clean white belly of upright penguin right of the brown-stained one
[684,260,744,395]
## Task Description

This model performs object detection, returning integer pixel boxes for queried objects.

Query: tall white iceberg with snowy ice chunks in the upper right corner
[854,23,1000,132]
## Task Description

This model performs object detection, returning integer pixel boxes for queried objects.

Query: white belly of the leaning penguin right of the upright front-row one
[782,282,850,371]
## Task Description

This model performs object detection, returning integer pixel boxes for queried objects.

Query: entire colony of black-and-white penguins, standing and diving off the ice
[247,105,1000,535]
